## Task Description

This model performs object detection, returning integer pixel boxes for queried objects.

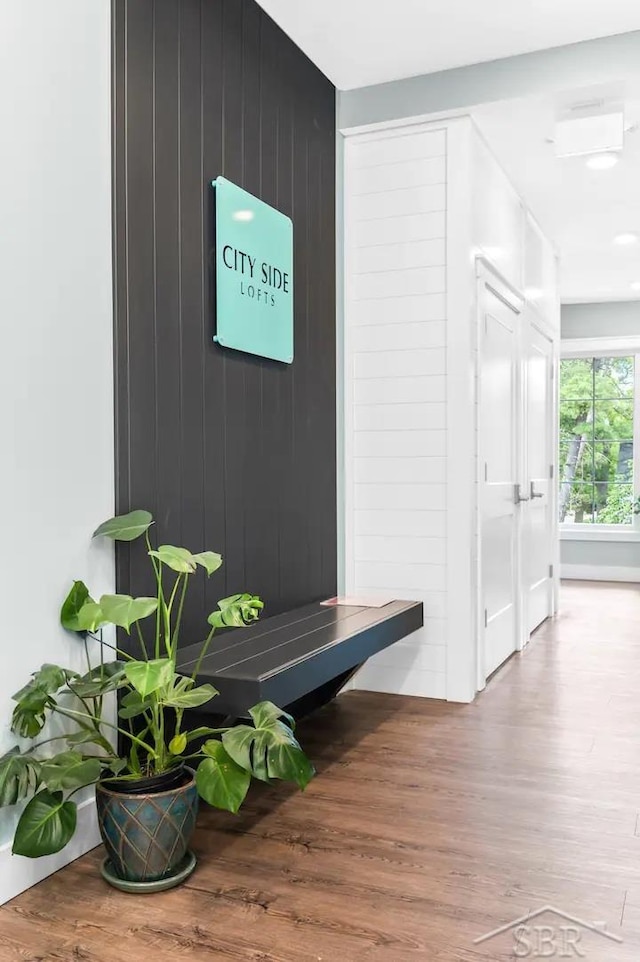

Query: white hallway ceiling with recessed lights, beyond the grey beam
[473,86,640,302]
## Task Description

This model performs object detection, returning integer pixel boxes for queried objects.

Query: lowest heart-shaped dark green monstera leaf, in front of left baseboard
[13,789,77,858]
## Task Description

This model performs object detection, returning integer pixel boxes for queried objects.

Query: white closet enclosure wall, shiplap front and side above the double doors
[341,117,558,701]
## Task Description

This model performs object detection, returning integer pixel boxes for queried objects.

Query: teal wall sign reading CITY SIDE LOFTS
[213,177,293,364]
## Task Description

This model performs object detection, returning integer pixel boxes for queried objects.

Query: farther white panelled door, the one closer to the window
[521,319,554,638]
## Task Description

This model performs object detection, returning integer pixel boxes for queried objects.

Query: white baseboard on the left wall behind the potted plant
[0,798,100,905]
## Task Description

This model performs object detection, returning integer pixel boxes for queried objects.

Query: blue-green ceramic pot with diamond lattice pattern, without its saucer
[96,768,198,882]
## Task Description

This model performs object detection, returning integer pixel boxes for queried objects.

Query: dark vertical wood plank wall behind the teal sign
[112,0,336,641]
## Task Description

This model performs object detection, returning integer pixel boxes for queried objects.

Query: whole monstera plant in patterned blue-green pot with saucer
[0,511,314,891]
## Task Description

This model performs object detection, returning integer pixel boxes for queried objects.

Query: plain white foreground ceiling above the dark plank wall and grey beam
[258,0,640,90]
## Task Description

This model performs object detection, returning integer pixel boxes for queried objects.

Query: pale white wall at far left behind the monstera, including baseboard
[0,0,114,902]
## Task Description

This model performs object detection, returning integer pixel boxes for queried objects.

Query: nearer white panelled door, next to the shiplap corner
[478,275,526,678]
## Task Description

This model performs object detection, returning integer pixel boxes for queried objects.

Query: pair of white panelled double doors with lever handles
[478,270,556,684]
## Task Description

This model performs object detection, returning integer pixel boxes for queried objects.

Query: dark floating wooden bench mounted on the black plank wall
[179,601,423,718]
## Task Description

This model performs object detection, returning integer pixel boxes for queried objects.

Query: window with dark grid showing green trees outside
[558,354,640,527]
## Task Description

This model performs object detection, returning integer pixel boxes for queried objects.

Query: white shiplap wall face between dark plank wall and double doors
[344,129,447,698]
